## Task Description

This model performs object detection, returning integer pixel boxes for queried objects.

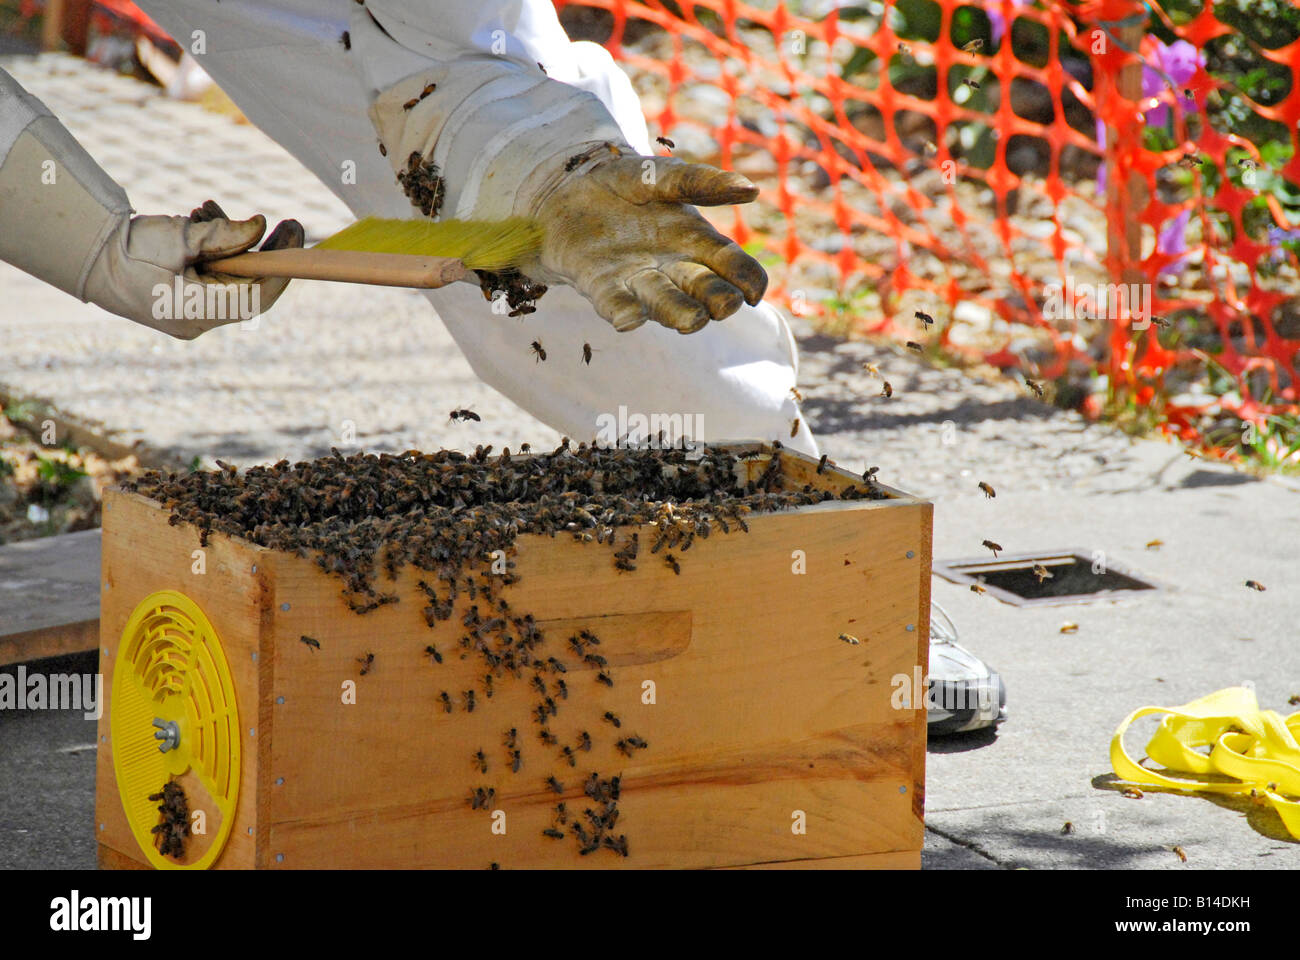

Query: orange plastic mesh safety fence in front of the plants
[556,0,1300,447]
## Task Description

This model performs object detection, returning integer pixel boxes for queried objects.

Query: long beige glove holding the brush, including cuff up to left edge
[0,70,303,340]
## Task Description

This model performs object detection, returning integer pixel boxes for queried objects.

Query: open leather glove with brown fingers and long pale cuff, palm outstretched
[366,62,767,333]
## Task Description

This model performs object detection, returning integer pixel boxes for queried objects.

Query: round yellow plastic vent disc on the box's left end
[111,591,241,870]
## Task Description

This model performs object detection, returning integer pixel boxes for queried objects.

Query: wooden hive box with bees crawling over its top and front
[96,445,932,869]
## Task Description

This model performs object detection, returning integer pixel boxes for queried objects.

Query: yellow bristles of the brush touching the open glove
[316,217,542,271]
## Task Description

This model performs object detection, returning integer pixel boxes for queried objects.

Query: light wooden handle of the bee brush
[213,247,465,289]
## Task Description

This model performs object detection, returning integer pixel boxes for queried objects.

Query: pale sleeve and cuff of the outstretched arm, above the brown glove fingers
[352,0,649,219]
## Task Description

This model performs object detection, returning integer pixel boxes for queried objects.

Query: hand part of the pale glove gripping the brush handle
[83,200,304,340]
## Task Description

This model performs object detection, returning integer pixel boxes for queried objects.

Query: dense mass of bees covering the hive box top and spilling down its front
[127,442,885,856]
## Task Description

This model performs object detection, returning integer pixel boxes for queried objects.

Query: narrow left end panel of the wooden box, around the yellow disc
[95,490,270,868]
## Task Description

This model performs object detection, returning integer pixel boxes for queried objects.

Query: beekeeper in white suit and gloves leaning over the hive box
[0,0,816,453]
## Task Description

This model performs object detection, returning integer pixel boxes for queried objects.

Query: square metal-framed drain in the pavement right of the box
[933,548,1164,606]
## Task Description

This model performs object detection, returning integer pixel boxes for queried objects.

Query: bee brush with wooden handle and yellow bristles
[204,217,542,289]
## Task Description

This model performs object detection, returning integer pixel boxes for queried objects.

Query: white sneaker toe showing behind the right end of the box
[926,602,1006,736]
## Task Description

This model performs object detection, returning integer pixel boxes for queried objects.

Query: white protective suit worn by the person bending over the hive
[10,0,816,455]
